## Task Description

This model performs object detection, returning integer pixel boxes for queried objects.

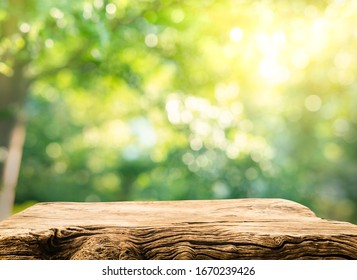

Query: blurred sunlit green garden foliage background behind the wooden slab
[0,0,357,223]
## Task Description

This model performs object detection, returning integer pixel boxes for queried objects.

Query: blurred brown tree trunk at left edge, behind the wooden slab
[0,67,28,220]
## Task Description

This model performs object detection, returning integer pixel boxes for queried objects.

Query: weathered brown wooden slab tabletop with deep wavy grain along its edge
[0,199,357,260]
